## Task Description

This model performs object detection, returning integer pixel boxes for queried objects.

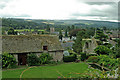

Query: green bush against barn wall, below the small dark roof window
[39,53,53,64]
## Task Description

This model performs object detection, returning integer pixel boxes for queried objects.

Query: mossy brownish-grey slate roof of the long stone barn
[2,35,63,53]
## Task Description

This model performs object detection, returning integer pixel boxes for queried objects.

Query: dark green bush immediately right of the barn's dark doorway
[27,53,40,66]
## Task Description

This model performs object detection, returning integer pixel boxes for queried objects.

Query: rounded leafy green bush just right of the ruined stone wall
[94,45,112,55]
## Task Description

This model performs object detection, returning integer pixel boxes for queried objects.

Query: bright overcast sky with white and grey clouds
[0,0,119,21]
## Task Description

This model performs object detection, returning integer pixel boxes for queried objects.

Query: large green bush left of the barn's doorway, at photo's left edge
[2,53,17,68]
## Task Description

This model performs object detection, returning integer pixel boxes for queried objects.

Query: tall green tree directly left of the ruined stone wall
[73,31,85,54]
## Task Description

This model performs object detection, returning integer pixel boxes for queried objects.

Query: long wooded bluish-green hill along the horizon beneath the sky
[2,18,120,29]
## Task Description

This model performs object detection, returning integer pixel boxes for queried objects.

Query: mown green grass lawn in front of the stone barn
[2,63,101,78]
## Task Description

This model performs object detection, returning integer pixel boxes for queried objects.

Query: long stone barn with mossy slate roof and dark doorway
[2,35,64,65]
